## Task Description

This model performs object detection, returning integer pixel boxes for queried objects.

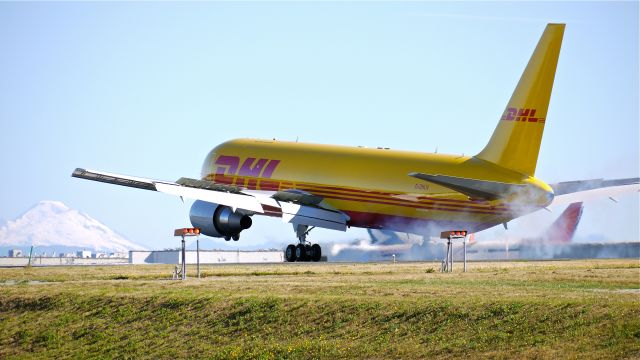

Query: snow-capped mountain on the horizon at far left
[0,201,145,252]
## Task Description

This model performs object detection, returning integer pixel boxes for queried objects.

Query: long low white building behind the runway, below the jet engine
[129,249,284,264]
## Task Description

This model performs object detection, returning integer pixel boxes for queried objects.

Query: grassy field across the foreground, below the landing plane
[0,260,640,359]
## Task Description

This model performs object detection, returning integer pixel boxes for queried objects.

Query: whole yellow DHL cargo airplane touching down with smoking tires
[72,24,637,261]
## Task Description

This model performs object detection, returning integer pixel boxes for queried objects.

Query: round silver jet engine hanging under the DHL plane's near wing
[189,200,252,240]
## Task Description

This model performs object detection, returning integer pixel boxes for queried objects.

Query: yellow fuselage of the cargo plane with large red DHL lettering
[201,139,552,235]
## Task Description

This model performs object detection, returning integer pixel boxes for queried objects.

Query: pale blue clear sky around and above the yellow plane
[0,2,640,247]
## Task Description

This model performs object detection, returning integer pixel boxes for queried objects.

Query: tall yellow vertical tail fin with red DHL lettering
[476,24,565,176]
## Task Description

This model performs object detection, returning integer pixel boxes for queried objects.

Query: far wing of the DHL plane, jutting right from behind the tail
[549,178,640,205]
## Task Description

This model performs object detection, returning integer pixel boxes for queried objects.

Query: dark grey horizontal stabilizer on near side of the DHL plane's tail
[409,173,527,200]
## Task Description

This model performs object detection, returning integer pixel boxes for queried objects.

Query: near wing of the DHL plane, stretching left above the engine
[71,168,349,231]
